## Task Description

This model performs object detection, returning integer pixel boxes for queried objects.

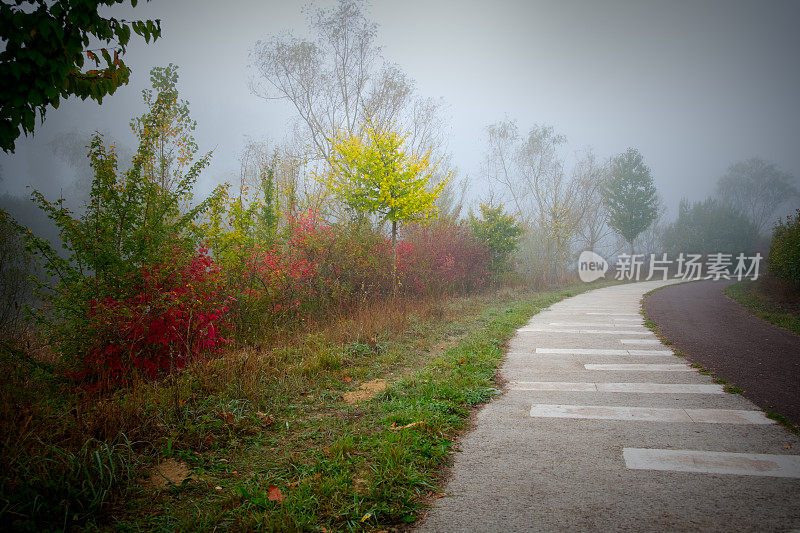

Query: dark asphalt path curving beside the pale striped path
[644,281,800,424]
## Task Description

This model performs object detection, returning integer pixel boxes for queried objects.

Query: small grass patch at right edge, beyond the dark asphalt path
[725,279,800,335]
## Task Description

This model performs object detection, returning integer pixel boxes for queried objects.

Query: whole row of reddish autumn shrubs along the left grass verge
[75,213,490,389]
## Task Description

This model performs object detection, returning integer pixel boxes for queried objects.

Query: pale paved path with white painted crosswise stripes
[419,282,800,532]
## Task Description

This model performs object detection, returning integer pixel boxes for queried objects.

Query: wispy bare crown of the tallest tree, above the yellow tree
[250,0,441,161]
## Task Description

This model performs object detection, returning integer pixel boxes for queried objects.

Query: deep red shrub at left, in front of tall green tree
[75,248,228,388]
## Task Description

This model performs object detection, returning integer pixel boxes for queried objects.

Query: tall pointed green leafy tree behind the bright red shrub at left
[17,65,221,375]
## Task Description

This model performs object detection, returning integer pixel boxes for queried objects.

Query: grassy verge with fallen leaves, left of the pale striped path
[0,285,612,531]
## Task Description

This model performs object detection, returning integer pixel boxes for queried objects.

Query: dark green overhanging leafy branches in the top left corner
[0,0,161,152]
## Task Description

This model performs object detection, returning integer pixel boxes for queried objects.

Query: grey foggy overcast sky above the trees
[0,0,800,218]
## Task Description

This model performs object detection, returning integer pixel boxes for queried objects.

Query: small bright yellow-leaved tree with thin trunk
[328,126,450,291]
